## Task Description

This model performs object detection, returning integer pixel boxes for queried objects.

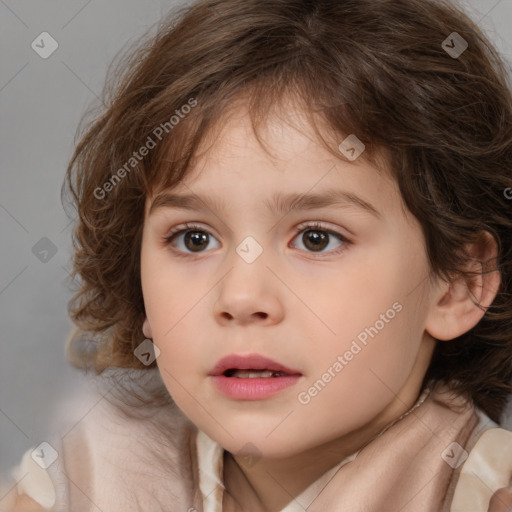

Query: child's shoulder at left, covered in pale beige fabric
[2,372,196,512]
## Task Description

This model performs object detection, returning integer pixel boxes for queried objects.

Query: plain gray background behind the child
[0,0,512,474]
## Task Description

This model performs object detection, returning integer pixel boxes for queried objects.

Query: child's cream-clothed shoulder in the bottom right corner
[450,412,512,512]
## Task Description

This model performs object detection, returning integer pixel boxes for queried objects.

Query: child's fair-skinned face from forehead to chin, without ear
[141,106,434,458]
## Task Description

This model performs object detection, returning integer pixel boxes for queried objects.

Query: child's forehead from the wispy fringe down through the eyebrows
[147,99,408,223]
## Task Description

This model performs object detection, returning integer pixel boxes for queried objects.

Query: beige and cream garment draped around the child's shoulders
[0,372,512,512]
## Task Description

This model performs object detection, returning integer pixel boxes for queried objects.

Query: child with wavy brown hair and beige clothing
[4,0,512,512]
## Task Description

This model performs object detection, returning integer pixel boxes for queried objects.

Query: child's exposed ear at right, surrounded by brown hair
[425,231,501,340]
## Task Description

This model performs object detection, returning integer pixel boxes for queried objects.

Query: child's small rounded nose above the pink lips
[214,251,284,325]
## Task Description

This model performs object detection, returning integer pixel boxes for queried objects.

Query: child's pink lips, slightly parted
[209,354,302,400]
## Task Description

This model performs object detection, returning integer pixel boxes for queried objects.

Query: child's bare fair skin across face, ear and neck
[141,103,499,512]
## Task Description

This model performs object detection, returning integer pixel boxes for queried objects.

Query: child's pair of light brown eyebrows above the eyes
[148,190,381,219]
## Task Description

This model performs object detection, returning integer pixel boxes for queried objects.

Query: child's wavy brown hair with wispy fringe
[64,0,512,421]
